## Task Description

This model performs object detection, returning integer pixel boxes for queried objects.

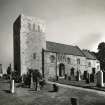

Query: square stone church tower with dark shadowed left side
[13,14,46,75]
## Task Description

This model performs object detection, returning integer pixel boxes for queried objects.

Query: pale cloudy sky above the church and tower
[0,0,105,72]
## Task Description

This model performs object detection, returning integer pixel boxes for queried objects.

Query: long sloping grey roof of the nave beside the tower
[46,41,85,57]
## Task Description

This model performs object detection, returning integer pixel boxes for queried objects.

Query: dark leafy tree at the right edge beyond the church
[97,42,105,71]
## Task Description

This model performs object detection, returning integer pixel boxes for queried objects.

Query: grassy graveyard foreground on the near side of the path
[0,80,105,105]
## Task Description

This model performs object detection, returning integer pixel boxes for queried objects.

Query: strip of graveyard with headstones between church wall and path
[54,71,105,91]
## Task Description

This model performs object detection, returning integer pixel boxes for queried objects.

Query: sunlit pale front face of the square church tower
[20,15,46,74]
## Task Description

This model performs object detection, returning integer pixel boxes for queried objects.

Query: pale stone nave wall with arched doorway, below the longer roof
[44,51,86,78]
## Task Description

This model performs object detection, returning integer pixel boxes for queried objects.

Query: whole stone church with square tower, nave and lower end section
[13,14,100,78]
